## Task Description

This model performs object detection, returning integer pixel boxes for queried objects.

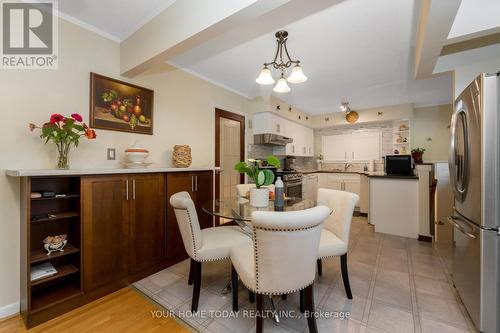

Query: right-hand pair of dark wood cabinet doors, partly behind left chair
[167,171,213,265]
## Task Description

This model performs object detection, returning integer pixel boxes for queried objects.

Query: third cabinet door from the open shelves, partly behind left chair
[166,172,196,265]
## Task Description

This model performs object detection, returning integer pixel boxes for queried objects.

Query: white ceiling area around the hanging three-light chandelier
[169,0,452,115]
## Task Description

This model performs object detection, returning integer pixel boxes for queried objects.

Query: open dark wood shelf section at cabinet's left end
[21,177,83,327]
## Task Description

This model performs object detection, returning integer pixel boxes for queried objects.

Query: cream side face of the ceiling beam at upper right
[415,0,462,79]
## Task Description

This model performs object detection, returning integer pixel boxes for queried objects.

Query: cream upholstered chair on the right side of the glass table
[317,188,359,299]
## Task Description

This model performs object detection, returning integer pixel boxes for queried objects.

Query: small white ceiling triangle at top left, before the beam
[59,0,176,41]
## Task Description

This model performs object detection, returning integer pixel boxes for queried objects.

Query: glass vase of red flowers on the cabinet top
[29,113,96,169]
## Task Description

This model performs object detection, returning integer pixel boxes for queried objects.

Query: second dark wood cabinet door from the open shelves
[129,173,166,273]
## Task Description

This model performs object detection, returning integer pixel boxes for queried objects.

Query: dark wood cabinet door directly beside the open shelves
[82,175,130,292]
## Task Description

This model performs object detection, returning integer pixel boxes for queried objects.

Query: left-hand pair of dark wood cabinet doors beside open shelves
[82,173,165,292]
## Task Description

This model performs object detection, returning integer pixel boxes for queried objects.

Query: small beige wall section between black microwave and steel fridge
[411,104,453,162]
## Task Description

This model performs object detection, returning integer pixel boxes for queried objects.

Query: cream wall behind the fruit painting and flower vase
[0,20,248,317]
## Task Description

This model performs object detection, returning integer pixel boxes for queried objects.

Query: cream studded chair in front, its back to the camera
[230,206,330,333]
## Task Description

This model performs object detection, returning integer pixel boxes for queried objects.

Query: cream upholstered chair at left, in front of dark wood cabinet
[170,192,252,312]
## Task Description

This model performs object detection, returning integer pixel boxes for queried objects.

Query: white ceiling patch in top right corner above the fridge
[448,0,500,39]
